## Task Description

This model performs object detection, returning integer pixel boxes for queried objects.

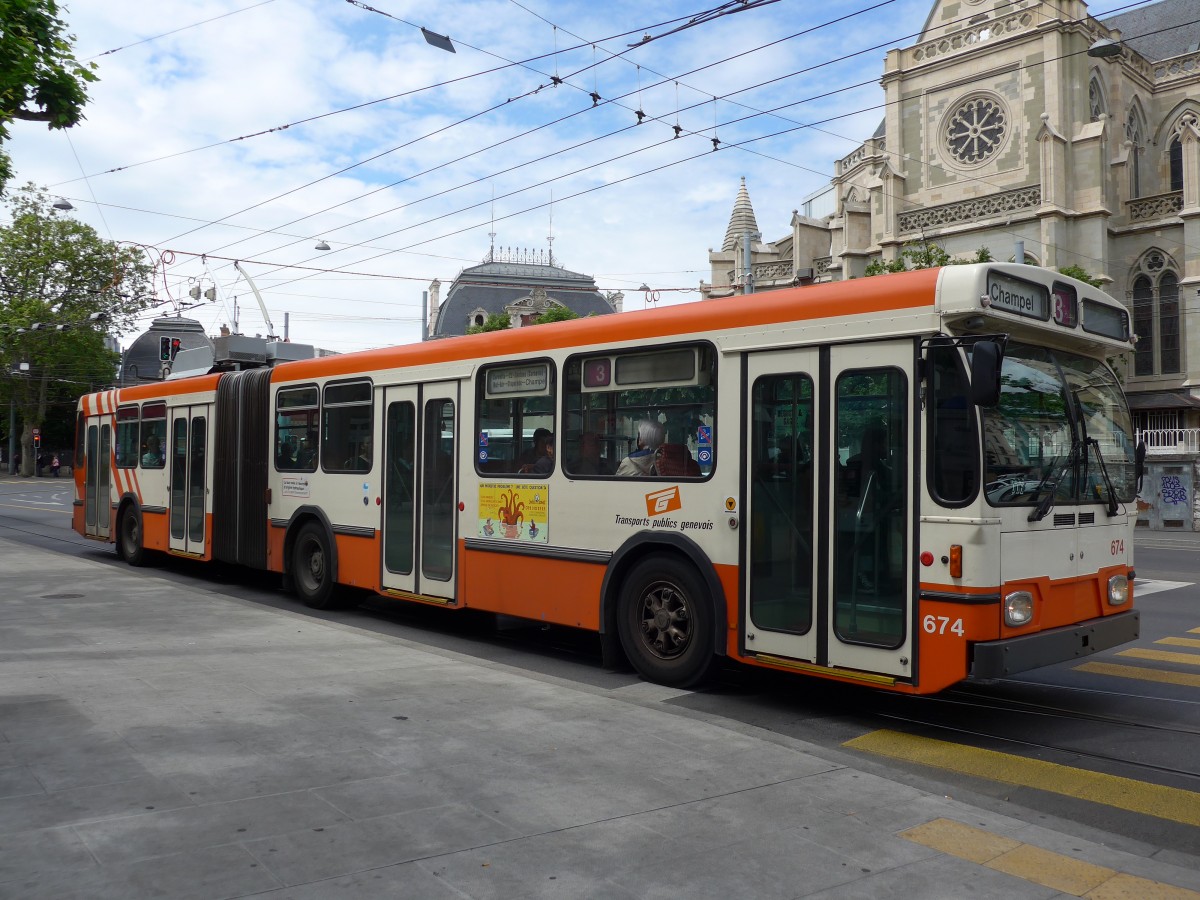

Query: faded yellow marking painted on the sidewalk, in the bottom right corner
[900,818,1200,900]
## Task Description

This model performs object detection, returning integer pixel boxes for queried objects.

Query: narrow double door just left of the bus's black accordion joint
[167,406,209,557]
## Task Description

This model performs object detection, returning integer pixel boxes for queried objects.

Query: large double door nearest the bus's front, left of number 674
[743,342,913,677]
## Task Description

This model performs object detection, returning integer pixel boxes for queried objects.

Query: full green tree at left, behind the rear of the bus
[0,185,152,475]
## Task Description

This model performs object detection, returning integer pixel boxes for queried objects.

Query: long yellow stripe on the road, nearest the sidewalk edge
[842,730,1200,826]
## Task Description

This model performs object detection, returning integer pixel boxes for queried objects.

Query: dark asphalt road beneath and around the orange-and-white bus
[0,479,1200,854]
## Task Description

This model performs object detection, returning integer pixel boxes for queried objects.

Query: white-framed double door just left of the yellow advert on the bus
[382,383,458,602]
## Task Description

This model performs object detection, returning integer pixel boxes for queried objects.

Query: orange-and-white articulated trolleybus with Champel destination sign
[73,264,1141,694]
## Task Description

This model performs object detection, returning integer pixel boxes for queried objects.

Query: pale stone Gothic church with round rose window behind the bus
[701,0,1200,528]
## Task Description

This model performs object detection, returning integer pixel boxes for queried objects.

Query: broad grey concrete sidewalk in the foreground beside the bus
[0,539,1200,900]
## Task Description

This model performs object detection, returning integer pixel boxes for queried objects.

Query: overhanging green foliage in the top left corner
[0,0,97,193]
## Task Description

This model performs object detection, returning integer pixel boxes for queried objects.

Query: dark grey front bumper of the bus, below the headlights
[971,610,1140,678]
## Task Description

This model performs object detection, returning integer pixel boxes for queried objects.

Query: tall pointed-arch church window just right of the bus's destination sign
[1130,250,1183,376]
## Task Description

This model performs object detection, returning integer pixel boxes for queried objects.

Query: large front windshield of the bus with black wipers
[983,343,1135,505]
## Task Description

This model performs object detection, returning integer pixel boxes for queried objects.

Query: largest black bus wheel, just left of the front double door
[617,556,718,688]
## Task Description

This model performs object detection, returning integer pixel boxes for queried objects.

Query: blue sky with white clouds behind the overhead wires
[8,0,945,352]
